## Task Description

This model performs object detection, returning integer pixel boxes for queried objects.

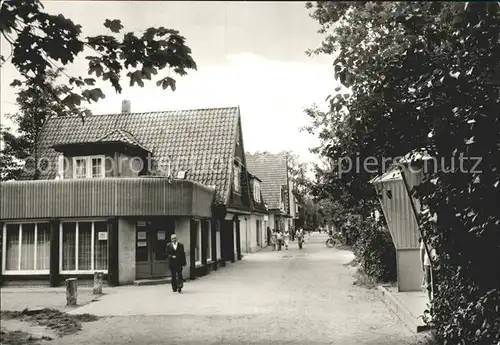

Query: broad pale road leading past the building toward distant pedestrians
[50,234,430,345]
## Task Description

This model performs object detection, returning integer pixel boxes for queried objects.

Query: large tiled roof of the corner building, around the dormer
[23,107,240,204]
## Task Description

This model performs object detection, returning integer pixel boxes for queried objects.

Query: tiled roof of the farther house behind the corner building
[245,153,288,209]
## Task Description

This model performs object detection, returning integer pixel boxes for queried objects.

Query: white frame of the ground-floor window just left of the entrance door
[59,218,109,274]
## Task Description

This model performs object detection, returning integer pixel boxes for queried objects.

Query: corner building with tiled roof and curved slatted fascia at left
[0,102,258,286]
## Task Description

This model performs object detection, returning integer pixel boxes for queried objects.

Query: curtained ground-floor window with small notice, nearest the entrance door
[60,221,108,273]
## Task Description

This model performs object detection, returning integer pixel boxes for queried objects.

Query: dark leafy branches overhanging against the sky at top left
[0,0,196,114]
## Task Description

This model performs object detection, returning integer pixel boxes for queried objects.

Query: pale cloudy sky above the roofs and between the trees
[1,1,336,162]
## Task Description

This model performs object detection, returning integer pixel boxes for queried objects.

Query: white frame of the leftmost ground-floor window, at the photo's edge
[1,219,50,275]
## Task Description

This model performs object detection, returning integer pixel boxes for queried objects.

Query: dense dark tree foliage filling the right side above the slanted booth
[307,1,500,344]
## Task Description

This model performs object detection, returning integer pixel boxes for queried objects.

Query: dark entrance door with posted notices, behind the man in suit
[135,220,174,279]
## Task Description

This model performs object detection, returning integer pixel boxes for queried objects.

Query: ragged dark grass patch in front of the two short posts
[0,308,99,336]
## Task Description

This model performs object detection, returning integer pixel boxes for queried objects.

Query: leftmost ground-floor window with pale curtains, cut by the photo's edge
[3,223,50,274]
